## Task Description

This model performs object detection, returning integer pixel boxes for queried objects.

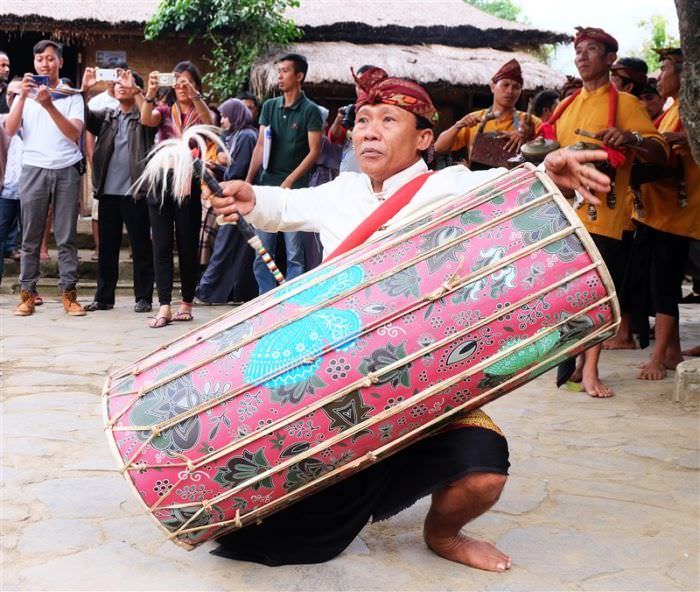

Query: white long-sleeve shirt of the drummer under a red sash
[245,159,505,257]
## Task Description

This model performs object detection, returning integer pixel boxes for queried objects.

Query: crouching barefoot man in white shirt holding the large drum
[211,69,609,571]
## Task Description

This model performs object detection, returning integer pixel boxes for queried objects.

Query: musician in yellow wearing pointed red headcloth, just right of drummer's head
[435,59,541,168]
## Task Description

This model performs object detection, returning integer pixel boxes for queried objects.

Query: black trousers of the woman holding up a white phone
[148,190,202,306]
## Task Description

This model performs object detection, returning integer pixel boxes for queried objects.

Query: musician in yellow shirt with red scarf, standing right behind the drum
[539,27,667,397]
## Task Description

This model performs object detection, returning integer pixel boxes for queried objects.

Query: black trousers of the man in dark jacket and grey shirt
[95,195,153,304]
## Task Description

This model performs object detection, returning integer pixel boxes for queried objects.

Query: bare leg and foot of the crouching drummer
[423,473,511,571]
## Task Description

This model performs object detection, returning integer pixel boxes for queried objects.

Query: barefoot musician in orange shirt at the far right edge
[634,48,700,380]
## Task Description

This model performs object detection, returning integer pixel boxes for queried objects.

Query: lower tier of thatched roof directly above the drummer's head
[251,42,565,95]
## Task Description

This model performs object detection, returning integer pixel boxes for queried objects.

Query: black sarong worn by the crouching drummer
[212,416,510,566]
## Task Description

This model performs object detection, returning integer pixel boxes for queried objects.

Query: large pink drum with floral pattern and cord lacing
[104,165,619,548]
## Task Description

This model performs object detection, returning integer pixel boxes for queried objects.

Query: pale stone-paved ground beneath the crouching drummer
[0,295,700,592]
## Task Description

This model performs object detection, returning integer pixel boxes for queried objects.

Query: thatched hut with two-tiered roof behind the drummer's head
[251,0,571,122]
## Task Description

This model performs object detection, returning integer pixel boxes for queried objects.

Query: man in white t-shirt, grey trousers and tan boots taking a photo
[5,39,85,316]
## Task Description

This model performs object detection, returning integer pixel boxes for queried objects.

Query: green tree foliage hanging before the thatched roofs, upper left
[145,0,301,99]
